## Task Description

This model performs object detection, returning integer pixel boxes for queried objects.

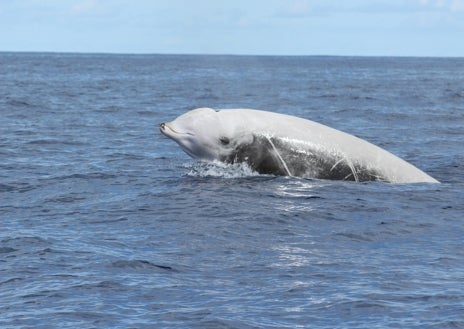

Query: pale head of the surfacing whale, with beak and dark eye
[160,108,252,160]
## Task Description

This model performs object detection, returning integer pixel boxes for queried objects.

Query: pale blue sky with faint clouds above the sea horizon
[0,0,464,57]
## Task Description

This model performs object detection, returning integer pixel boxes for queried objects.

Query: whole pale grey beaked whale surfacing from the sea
[160,108,439,183]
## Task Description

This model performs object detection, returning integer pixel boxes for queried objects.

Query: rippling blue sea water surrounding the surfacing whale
[0,53,464,328]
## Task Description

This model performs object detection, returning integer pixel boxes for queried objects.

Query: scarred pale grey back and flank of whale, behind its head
[219,109,437,183]
